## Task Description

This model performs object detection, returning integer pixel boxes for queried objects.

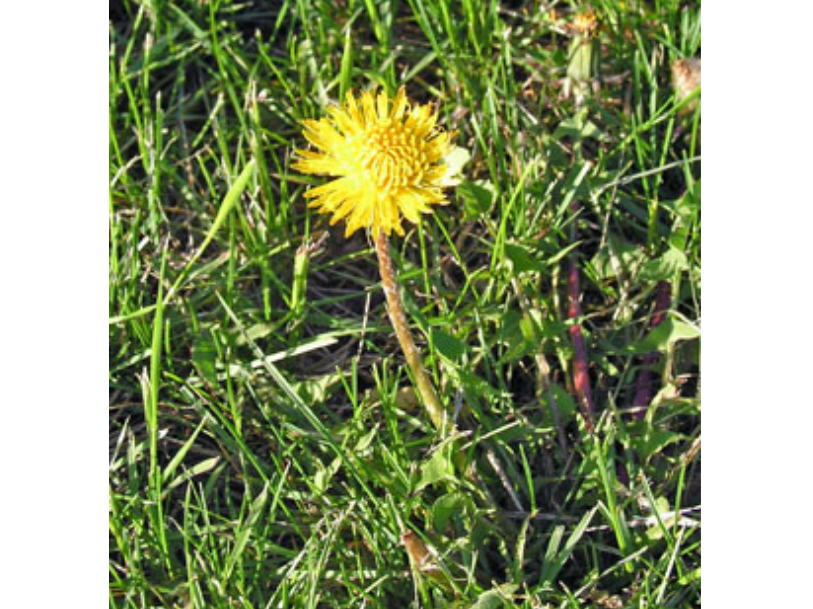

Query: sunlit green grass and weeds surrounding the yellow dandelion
[109,0,700,609]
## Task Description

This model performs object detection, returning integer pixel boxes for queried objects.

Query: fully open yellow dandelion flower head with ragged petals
[293,87,454,237]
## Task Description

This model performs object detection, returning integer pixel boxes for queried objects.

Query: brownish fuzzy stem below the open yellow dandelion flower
[375,230,446,432]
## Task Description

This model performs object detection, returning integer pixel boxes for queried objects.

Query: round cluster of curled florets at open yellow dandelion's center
[358,120,427,191]
